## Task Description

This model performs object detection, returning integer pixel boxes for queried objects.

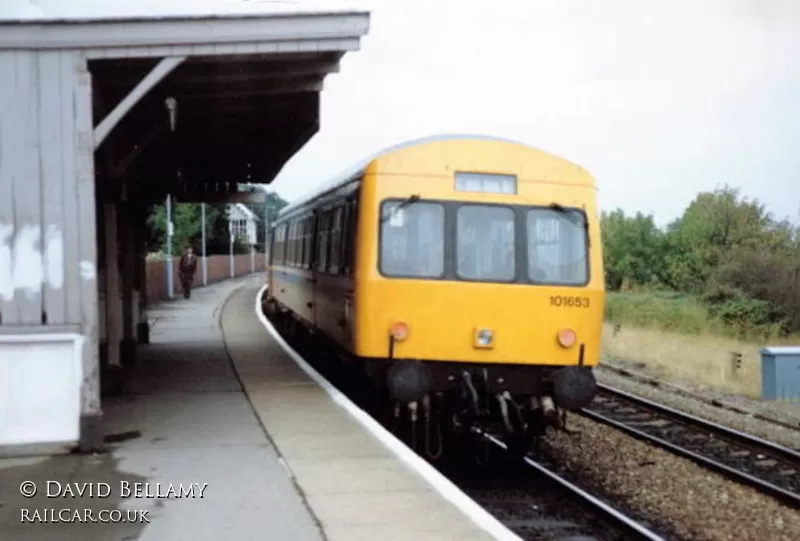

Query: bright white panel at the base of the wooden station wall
[0,334,83,446]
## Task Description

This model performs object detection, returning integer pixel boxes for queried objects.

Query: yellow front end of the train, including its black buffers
[352,139,605,409]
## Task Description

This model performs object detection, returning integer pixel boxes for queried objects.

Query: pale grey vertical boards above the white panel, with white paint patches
[0,51,81,326]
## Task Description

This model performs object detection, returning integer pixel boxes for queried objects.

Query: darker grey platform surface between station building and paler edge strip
[0,275,323,541]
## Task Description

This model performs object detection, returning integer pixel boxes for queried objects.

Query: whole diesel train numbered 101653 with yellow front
[263,135,605,456]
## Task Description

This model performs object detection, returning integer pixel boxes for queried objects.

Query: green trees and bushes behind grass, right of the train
[601,186,800,333]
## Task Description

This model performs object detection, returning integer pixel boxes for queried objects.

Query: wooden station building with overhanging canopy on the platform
[0,0,369,454]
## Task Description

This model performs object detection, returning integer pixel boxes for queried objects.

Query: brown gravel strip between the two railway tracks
[545,415,800,541]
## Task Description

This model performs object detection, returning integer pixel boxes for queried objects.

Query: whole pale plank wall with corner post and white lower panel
[0,50,99,445]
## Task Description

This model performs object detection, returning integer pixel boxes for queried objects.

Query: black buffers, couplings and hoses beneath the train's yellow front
[364,340,597,458]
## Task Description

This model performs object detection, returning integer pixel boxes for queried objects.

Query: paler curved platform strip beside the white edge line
[222,280,492,541]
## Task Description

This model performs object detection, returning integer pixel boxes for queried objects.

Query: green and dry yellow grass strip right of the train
[603,292,800,398]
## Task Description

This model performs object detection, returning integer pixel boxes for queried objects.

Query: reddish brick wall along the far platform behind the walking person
[147,254,265,302]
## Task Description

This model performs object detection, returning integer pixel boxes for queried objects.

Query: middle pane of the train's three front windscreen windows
[456,205,516,282]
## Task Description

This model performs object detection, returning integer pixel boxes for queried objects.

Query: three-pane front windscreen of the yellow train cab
[380,196,589,286]
